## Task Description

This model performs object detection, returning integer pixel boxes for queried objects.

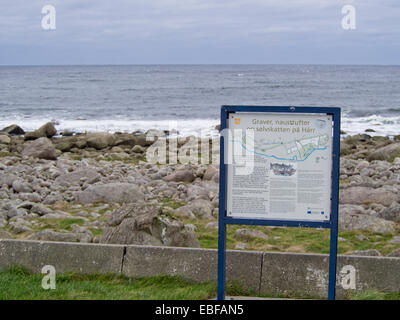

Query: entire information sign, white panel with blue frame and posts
[218,106,340,299]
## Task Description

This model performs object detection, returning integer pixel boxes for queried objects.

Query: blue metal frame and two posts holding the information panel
[217,105,340,300]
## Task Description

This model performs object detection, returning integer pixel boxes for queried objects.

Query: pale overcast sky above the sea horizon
[0,0,400,65]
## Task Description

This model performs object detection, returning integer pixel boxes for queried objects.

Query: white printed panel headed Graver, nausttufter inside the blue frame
[225,112,332,221]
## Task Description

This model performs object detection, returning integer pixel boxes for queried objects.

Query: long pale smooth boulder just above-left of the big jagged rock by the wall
[75,182,144,204]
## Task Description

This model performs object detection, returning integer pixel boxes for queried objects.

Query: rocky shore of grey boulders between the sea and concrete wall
[0,123,400,256]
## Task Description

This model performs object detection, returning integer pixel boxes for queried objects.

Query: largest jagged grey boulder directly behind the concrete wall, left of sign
[100,203,199,247]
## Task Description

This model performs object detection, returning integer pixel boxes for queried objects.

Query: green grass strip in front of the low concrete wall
[0,266,400,300]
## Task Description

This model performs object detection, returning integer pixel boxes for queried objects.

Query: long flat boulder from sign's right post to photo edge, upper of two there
[339,187,399,206]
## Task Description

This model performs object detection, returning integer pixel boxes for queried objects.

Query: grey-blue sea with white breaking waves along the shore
[0,65,400,136]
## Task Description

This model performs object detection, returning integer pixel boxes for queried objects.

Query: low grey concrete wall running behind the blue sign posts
[0,240,400,297]
